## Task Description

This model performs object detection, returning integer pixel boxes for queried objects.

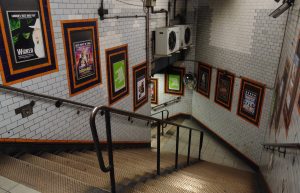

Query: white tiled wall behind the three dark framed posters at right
[192,0,287,163]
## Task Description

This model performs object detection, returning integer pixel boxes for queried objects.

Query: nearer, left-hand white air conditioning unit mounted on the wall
[155,26,180,56]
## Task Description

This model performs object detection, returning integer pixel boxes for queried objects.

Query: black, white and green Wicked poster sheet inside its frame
[7,11,45,63]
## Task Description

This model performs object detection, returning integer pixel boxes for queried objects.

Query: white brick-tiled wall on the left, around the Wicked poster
[0,0,180,141]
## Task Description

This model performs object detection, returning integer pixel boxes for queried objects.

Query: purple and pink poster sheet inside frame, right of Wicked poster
[73,40,96,80]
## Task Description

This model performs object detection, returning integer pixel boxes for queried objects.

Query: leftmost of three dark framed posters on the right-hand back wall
[197,62,212,98]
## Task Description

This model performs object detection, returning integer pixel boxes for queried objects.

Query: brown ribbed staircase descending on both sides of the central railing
[0,149,256,193]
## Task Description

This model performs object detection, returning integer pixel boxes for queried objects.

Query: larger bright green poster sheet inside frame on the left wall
[113,60,126,92]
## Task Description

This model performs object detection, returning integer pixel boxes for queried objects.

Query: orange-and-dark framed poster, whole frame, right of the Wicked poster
[61,19,101,96]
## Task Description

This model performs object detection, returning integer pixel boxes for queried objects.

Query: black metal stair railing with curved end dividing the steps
[90,106,204,193]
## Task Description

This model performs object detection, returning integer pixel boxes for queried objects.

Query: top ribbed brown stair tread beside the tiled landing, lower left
[0,155,100,193]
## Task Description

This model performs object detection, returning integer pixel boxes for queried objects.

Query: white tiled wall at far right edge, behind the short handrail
[260,0,300,193]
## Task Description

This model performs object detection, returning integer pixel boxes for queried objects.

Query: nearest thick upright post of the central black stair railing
[105,110,116,193]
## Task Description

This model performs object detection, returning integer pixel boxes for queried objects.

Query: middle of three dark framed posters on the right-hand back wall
[215,70,234,111]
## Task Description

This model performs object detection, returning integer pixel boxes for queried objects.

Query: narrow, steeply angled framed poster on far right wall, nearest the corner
[271,59,291,132]
